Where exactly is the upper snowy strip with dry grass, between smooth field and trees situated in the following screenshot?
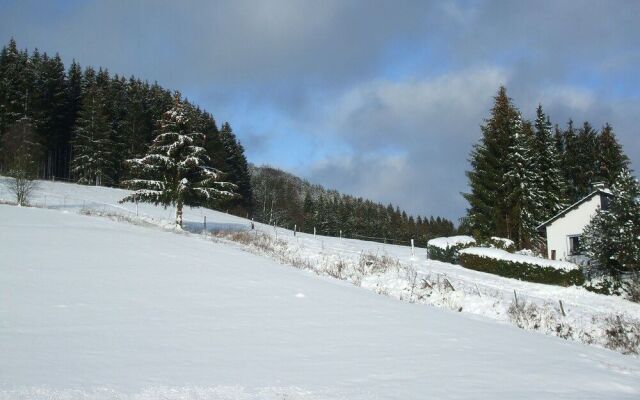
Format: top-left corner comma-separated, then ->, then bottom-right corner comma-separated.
0,177 -> 640,351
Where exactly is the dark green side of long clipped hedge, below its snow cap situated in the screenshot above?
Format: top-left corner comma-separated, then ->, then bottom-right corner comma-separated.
459,253 -> 584,286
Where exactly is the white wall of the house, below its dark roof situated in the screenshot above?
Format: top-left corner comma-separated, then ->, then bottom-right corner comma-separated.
547,195 -> 602,261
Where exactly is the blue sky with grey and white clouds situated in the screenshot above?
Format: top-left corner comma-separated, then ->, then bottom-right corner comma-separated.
0,0 -> 640,221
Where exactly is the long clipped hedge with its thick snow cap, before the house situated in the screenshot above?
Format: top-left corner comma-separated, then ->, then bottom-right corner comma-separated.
459,247 -> 584,286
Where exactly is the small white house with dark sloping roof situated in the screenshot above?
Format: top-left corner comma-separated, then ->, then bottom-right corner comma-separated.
538,185 -> 612,261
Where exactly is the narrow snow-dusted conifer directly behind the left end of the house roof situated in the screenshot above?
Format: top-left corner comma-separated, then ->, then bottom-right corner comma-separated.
532,105 -> 566,219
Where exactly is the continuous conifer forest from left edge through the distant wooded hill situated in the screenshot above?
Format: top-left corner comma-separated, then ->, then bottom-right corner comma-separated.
0,39 -> 456,245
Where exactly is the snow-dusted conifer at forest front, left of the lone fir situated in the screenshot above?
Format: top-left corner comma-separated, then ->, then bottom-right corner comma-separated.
71,68 -> 114,186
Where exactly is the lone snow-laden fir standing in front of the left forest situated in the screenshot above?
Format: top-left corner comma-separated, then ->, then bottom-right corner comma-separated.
121,92 -> 236,227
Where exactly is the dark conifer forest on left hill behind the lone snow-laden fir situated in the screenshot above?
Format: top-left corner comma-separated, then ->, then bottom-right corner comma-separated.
0,39 -> 252,213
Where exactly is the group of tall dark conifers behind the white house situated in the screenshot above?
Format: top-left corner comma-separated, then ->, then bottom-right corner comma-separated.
461,87 -> 629,248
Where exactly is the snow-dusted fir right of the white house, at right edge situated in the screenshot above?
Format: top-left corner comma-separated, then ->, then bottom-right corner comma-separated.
583,169 -> 640,274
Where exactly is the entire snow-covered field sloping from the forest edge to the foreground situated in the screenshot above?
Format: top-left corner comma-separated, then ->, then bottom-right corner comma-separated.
0,178 -> 640,399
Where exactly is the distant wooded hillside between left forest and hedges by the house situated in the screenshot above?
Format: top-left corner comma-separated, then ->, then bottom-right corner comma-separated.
251,166 -> 456,246
